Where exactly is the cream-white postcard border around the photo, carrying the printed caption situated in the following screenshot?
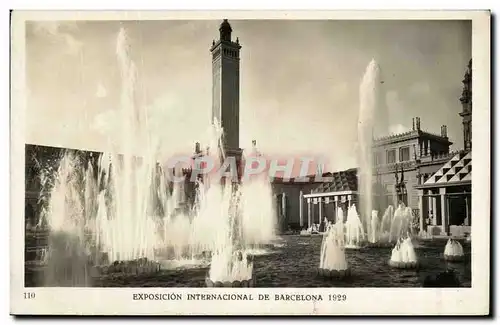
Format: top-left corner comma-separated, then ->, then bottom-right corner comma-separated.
10,11 -> 490,315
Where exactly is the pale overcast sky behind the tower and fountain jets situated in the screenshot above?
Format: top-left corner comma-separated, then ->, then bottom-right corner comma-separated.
26,20 -> 471,170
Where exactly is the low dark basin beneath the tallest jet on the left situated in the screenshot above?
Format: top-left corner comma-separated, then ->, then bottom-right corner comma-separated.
91,258 -> 161,277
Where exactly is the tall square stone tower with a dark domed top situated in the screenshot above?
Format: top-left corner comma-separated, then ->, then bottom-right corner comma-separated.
210,19 -> 241,155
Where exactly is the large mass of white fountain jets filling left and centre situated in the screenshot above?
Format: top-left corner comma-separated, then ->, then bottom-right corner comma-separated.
38,28 -> 275,286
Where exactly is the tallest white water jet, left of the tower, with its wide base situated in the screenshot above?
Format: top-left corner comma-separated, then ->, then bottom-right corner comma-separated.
90,28 -> 164,261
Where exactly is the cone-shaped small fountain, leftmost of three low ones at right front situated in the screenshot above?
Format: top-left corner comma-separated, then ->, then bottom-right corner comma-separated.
318,221 -> 351,279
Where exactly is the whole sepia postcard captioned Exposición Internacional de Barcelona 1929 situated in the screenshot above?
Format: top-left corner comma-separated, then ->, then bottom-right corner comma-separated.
10,11 -> 490,315
